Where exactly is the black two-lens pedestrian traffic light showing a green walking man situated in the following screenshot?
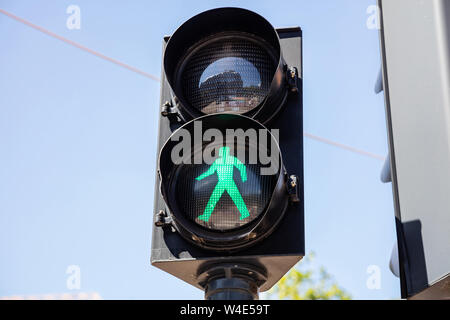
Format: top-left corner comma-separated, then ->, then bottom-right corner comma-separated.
151,8 -> 304,299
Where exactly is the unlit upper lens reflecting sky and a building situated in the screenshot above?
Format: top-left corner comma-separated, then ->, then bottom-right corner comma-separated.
181,35 -> 276,114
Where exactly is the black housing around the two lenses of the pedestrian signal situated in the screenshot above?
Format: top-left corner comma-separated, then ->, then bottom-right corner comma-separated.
151,8 -> 305,291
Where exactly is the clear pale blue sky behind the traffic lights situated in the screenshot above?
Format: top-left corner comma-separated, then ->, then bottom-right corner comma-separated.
0,0 -> 400,299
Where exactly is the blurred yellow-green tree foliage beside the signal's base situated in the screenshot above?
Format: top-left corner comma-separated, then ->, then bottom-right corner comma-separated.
268,253 -> 351,300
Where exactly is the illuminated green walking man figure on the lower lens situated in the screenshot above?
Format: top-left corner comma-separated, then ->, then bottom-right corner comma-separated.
195,147 -> 250,221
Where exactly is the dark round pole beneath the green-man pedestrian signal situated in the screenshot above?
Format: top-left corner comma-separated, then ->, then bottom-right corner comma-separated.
199,263 -> 267,300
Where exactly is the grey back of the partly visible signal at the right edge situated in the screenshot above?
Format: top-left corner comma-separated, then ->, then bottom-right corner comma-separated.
376,0 -> 450,299
